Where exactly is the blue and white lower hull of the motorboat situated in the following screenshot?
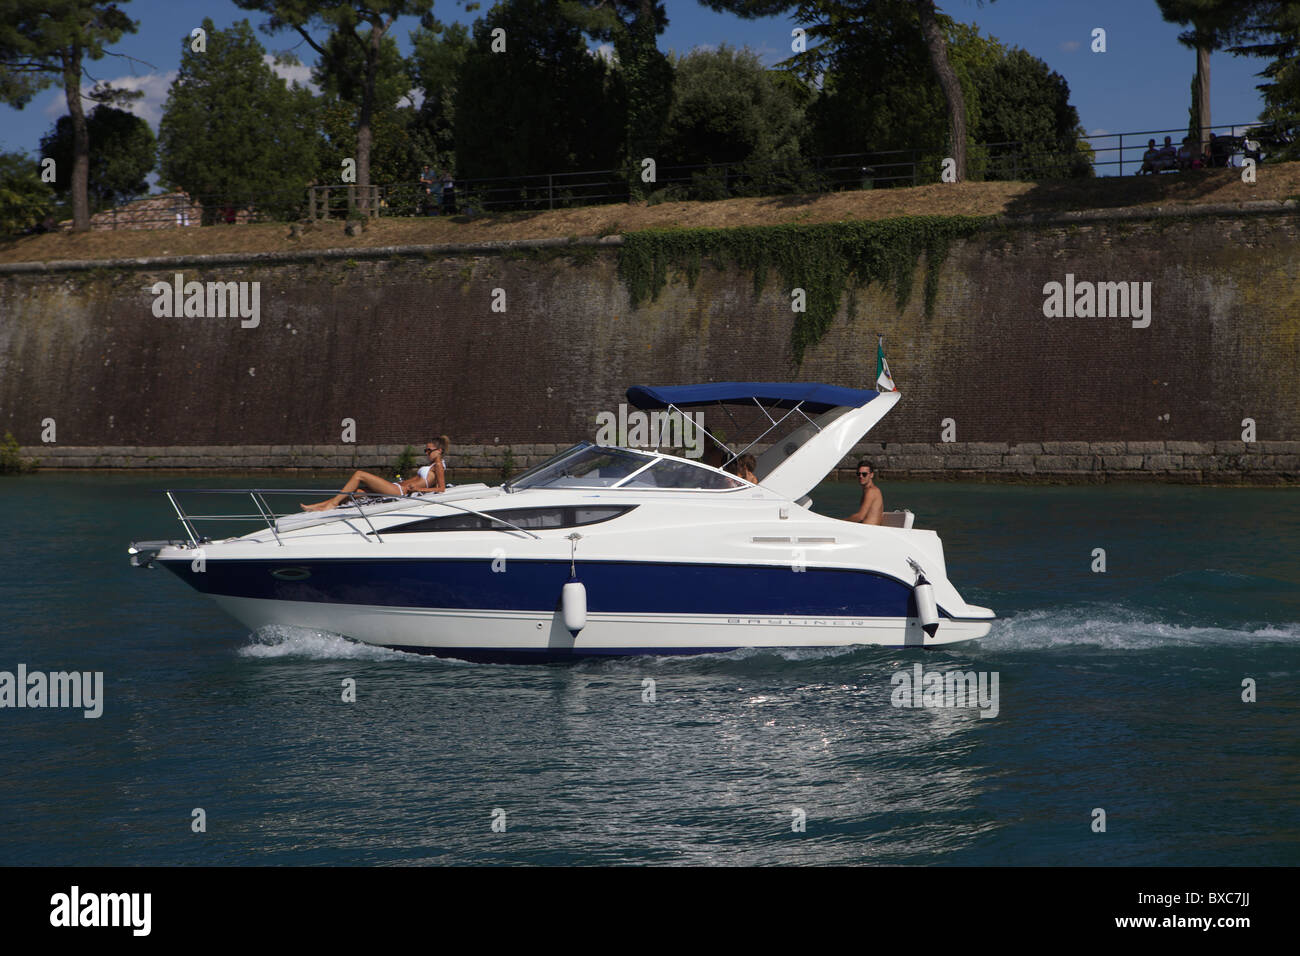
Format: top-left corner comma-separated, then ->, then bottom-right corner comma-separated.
161,559 -> 992,661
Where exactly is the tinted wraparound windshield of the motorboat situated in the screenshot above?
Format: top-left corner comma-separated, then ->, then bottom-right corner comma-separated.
510,445 -> 746,490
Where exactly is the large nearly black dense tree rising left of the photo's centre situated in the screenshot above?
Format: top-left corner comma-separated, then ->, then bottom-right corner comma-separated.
455,0 -> 621,192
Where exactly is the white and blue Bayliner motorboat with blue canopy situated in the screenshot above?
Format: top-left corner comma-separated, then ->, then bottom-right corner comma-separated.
130,382 -> 995,661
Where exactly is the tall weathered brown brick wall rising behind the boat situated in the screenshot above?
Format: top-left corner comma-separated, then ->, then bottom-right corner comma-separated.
0,205 -> 1300,480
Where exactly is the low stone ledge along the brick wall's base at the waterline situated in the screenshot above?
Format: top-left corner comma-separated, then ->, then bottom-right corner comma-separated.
21,441 -> 1300,484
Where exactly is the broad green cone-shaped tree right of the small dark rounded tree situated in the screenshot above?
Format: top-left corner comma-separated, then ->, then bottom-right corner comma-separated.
159,20 -> 316,222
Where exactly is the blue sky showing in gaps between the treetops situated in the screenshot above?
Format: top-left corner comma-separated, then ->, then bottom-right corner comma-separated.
0,0 -> 1265,172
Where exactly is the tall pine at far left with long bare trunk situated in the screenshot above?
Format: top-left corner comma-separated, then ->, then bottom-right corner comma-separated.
0,0 -> 137,229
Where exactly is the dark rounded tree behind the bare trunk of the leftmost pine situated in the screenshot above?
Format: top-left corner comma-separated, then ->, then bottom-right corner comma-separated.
40,103 -> 157,212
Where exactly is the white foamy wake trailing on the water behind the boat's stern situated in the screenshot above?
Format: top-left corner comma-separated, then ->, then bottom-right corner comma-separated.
980,606 -> 1300,650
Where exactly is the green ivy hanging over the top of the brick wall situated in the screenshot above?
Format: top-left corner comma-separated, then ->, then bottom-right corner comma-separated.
619,216 -> 987,364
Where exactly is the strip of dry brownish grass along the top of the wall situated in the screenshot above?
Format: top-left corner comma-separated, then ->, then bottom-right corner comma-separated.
0,163 -> 1300,263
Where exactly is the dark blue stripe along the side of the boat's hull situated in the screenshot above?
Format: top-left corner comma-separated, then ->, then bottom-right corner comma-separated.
161,559 -> 949,618
